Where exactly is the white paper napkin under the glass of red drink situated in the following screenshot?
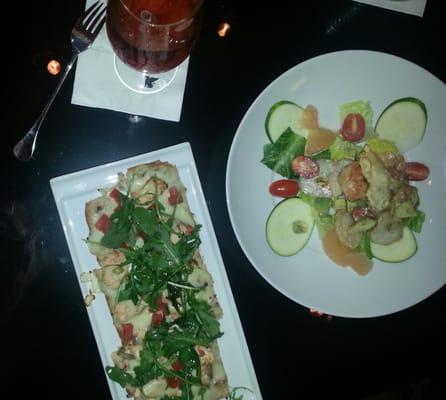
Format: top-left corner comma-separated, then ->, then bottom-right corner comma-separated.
71,0 -> 189,121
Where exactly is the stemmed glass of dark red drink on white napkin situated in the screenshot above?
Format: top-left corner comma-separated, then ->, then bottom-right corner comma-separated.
106,0 -> 204,94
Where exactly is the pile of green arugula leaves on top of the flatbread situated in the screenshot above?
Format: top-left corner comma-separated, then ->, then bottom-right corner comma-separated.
97,188 -> 222,400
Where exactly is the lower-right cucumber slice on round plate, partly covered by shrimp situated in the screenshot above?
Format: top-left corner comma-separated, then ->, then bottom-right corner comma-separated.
370,226 -> 417,263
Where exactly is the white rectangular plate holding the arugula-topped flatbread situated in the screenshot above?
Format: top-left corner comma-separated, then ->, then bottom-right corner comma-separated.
50,143 -> 261,400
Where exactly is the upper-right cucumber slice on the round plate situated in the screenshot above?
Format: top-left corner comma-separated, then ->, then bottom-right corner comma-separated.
375,97 -> 427,153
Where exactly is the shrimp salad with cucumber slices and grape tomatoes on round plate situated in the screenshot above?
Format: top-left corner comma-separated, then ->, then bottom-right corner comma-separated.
261,97 -> 429,275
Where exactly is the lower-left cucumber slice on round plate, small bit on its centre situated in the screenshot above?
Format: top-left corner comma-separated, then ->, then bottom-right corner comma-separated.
266,197 -> 314,256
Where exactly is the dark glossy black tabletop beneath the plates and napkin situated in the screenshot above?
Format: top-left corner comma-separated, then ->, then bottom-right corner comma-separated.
0,0 -> 446,399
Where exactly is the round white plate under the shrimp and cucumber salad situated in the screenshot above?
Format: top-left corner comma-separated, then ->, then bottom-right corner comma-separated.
226,50 -> 446,318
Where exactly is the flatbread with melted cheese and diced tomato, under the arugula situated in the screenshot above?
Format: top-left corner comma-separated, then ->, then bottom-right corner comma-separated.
85,161 -> 229,400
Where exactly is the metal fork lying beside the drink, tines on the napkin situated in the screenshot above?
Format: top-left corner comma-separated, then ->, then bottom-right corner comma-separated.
13,1 -> 106,161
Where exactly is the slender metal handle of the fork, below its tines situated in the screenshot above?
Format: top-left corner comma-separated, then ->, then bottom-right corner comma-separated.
13,52 -> 79,161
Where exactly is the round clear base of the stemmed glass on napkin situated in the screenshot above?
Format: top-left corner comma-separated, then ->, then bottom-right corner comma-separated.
113,55 -> 178,94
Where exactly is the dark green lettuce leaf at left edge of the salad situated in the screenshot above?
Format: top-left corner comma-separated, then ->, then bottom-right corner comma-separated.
262,128 -> 307,178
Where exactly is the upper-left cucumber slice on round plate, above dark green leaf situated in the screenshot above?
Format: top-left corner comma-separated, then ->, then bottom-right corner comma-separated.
265,100 -> 306,143
